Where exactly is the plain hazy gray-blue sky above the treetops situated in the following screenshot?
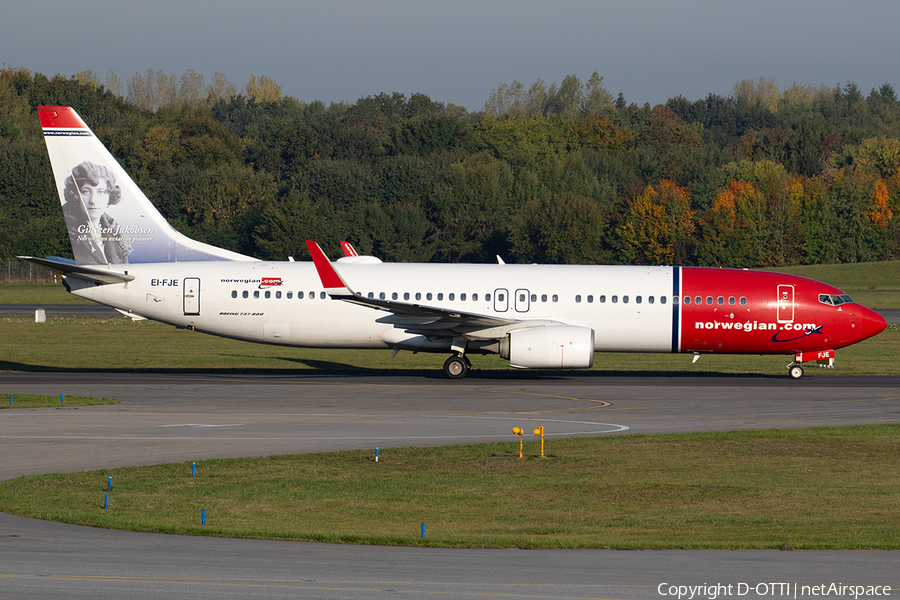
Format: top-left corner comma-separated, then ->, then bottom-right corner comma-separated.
0,0 -> 900,111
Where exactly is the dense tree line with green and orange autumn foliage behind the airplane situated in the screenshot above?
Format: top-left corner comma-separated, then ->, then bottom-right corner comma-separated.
0,68 -> 900,267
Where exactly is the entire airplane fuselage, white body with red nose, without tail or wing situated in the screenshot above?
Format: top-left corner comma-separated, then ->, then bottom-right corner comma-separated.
65,261 -> 883,354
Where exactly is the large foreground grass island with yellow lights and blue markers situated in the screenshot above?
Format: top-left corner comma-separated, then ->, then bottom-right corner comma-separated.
0,425 -> 900,549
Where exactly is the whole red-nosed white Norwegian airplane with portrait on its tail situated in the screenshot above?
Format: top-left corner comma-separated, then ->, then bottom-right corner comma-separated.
23,106 -> 886,378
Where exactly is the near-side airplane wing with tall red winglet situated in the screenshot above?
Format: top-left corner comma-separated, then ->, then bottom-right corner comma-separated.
306,241 -> 534,338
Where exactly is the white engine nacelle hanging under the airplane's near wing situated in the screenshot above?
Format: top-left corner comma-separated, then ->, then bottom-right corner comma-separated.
500,325 -> 594,369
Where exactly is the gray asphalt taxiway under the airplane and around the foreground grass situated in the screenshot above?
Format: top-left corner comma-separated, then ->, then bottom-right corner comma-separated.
0,373 -> 900,599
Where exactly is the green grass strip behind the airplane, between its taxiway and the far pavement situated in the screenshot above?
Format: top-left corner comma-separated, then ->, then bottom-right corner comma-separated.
0,317 -> 900,375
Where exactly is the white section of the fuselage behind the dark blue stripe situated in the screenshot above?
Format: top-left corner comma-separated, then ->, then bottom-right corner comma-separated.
70,261 -> 678,352
